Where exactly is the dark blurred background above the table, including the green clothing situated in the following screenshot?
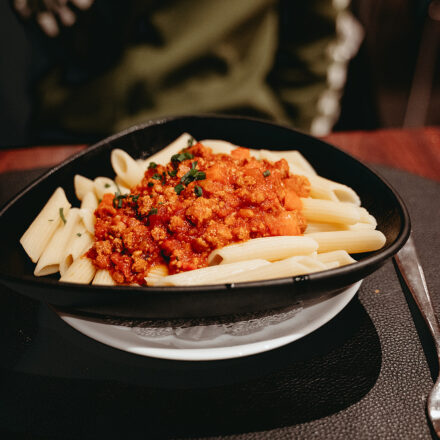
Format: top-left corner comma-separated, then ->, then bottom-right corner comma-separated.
0,0 -> 440,148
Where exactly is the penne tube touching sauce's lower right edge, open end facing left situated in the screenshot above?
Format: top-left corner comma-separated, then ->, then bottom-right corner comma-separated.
208,236 -> 318,266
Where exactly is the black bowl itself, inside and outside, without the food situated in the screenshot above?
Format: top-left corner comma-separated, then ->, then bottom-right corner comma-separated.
0,116 -> 410,318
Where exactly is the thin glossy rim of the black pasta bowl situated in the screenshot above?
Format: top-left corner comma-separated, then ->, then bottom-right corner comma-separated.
0,113 -> 411,295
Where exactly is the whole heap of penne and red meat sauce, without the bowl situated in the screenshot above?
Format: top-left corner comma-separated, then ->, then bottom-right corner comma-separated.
20,133 -> 386,286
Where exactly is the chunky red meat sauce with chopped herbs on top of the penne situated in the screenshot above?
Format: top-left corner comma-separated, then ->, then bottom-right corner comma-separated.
87,143 -> 310,285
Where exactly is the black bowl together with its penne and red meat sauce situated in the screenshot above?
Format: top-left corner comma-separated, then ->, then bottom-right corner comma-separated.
0,117 -> 409,317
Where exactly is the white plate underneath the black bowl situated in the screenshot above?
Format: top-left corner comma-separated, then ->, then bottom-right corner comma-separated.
57,281 -> 362,361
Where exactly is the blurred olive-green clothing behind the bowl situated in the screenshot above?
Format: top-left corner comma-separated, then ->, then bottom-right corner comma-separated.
36,0 -> 337,135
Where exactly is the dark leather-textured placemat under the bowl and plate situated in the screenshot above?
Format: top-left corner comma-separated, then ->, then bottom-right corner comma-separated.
0,167 -> 440,439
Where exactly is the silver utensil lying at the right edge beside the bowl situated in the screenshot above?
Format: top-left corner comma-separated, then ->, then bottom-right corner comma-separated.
394,235 -> 440,437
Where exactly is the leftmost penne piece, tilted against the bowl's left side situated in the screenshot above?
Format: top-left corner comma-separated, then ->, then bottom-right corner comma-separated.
20,188 -> 71,263
